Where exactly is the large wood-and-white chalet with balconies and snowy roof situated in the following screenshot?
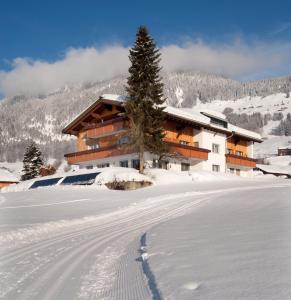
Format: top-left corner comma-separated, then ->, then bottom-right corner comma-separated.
63,94 -> 262,176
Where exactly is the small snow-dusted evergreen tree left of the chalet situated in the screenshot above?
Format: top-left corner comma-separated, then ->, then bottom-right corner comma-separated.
21,142 -> 43,180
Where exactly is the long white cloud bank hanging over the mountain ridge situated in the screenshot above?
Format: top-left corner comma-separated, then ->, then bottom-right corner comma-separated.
0,41 -> 291,96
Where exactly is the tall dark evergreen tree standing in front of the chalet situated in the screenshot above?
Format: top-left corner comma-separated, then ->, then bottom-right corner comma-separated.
125,26 -> 166,173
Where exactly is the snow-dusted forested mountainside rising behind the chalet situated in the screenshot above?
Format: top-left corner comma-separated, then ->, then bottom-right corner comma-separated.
0,72 -> 291,162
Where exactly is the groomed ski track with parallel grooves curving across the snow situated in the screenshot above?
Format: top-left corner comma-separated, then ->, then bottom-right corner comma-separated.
0,180 -> 286,300
